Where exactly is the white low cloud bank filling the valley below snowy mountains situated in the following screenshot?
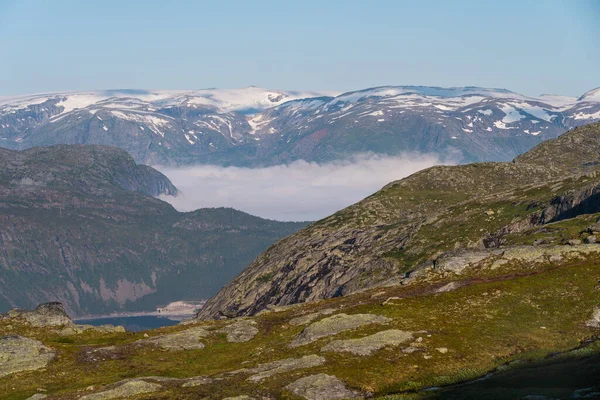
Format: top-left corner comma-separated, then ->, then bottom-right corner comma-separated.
159,154 -> 448,221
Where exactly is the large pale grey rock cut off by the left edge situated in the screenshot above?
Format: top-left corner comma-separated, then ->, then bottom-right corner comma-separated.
0,336 -> 55,377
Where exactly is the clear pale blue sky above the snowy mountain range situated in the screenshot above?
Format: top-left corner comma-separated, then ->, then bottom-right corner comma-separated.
0,0 -> 600,96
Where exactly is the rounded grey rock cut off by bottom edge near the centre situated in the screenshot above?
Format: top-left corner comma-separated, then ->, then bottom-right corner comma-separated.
285,374 -> 363,400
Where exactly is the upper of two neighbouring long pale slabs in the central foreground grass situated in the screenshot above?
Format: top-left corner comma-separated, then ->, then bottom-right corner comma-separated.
290,313 -> 391,347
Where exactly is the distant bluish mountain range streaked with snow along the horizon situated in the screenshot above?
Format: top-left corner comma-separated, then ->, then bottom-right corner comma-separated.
0,86 -> 600,165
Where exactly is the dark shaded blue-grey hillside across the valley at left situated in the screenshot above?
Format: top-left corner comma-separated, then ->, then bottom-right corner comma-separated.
0,145 -> 303,315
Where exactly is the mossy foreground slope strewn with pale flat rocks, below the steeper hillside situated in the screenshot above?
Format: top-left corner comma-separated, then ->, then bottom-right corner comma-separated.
0,230 -> 600,400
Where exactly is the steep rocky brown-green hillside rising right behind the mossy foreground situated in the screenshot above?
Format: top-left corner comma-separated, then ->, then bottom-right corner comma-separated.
199,124 -> 600,318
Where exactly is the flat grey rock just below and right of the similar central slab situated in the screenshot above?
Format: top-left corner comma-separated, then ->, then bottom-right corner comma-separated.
321,329 -> 412,356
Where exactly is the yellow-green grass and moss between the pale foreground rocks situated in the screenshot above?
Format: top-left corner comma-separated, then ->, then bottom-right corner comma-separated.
0,250 -> 600,399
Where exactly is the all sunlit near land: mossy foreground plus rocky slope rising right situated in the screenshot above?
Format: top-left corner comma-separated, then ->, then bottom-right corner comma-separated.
0,124 -> 600,400
